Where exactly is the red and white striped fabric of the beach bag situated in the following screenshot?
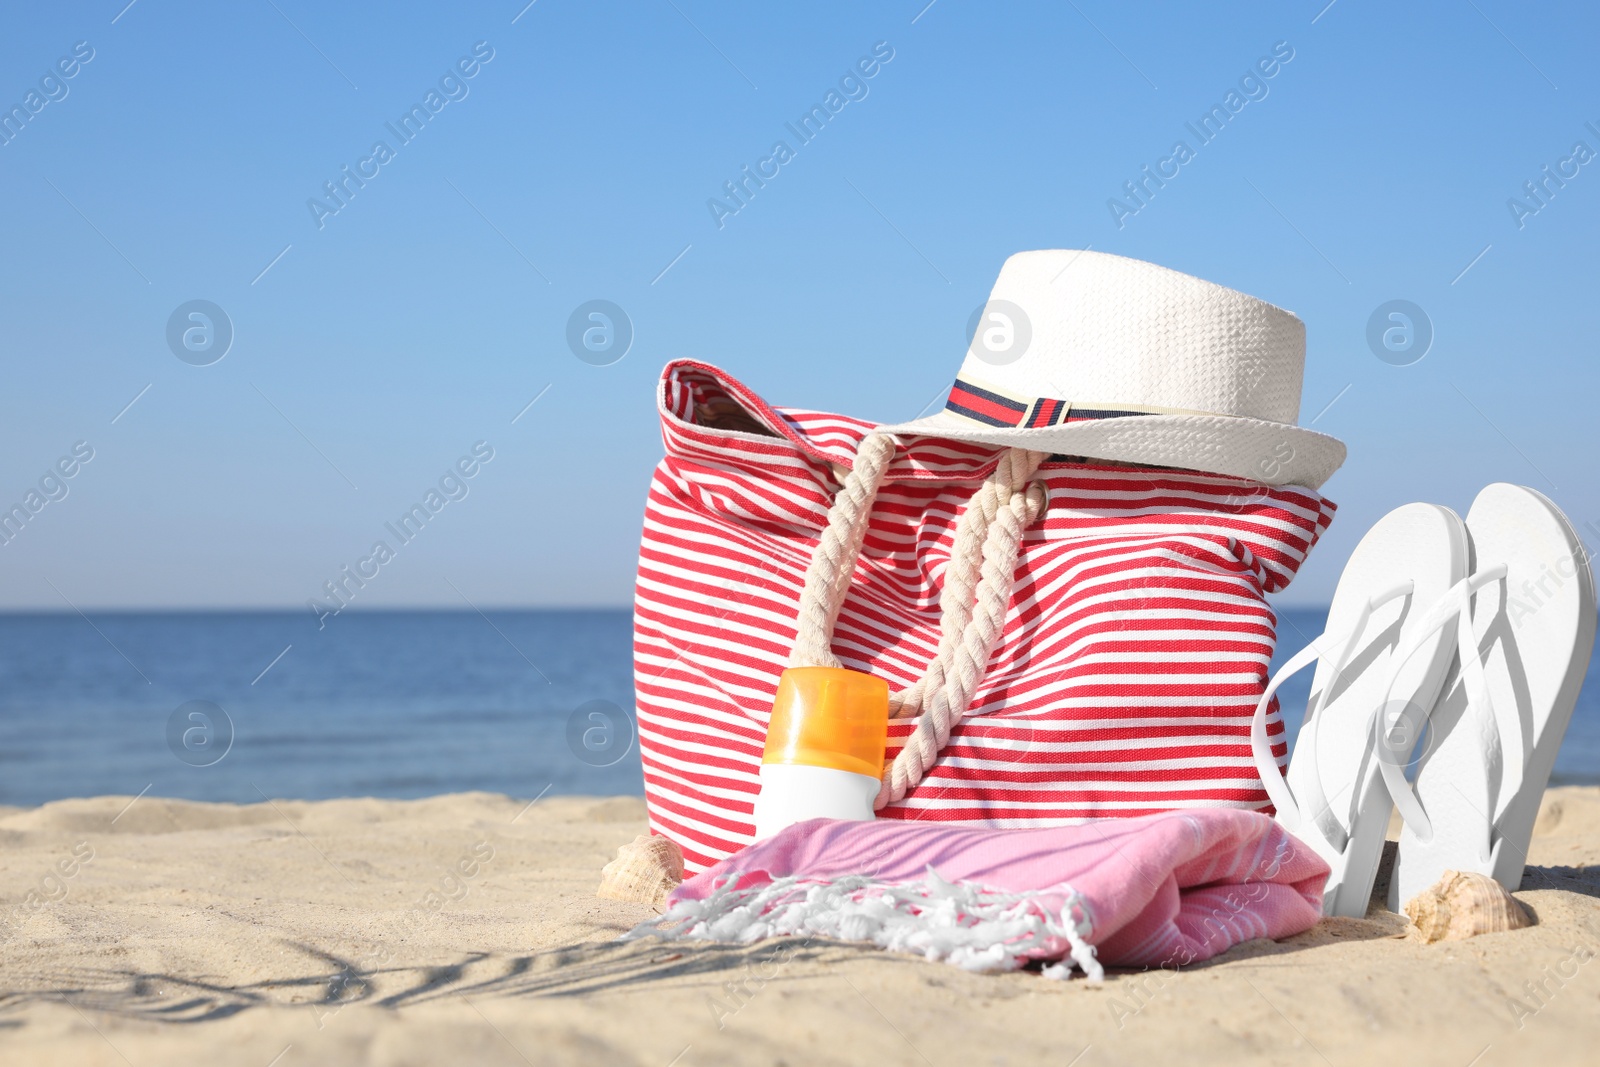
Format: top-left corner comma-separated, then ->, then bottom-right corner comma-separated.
634,360 -> 1334,873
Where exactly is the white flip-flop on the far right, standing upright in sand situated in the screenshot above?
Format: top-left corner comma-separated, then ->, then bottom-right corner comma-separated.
1382,482 -> 1595,910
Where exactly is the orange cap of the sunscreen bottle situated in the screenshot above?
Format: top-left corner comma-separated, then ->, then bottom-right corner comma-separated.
762,667 -> 890,777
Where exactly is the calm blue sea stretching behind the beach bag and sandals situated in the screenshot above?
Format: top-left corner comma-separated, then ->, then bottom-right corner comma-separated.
0,609 -> 1600,805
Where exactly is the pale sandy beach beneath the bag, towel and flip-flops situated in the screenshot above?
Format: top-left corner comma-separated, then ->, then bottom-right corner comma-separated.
0,787 -> 1600,1067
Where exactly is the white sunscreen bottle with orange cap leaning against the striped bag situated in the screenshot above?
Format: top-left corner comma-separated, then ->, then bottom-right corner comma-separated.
755,667 -> 890,840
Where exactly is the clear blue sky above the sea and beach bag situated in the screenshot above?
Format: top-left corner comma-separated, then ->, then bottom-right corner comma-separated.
0,0 -> 1600,609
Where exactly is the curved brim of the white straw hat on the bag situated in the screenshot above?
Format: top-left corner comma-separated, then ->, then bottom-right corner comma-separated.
878,411 -> 1346,490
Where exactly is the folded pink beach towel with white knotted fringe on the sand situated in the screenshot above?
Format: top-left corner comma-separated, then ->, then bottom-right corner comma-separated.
632,808 -> 1328,979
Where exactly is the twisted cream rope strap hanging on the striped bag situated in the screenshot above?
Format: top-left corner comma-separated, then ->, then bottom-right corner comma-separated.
789,434 -> 1046,808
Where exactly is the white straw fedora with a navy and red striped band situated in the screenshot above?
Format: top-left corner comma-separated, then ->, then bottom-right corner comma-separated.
880,250 -> 1344,490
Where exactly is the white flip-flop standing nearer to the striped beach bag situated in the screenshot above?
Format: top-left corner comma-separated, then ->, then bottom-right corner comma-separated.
1250,504 -> 1467,917
